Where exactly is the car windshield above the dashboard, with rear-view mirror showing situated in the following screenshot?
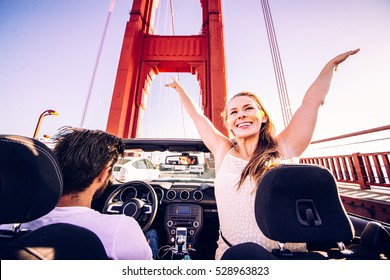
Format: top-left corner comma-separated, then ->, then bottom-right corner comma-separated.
113,139 -> 215,183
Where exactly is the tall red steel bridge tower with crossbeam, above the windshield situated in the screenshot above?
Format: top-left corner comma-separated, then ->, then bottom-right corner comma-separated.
106,0 -> 227,138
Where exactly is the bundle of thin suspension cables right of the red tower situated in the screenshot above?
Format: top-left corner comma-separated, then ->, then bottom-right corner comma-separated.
261,0 -> 292,127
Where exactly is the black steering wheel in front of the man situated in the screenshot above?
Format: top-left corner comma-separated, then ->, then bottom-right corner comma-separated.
103,181 -> 158,232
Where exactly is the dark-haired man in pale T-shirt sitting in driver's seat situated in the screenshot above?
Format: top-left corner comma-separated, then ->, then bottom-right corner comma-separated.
1,127 -> 152,260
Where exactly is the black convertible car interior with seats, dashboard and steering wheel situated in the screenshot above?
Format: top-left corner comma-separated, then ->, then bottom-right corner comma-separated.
0,135 -> 390,260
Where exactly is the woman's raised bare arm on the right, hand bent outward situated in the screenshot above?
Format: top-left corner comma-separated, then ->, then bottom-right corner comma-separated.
277,49 -> 359,158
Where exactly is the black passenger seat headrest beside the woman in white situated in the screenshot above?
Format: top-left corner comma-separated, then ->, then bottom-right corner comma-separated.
255,165 -> 354,243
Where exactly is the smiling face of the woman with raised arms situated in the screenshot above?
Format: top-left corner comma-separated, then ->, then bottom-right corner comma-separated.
226,96 -> 266,138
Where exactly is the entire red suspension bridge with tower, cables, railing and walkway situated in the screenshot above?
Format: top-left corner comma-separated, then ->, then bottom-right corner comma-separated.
80,0 -> 390,223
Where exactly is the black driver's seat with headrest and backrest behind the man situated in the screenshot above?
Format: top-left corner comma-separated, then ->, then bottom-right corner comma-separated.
0,135 -> 108,260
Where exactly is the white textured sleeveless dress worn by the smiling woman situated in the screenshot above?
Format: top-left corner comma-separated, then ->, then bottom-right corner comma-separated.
214,151 -> 306,260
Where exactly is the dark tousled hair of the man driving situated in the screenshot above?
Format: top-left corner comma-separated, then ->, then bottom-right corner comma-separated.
53,127 -> 124,194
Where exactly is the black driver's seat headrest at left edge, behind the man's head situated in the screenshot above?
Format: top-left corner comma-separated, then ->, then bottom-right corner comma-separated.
0,135 -> 63,224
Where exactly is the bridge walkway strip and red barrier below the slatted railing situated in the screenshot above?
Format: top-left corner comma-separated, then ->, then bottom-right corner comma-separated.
337,182 -> 390,224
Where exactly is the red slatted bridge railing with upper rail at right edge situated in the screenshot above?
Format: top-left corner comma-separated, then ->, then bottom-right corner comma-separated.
300,125 -> 390,189
